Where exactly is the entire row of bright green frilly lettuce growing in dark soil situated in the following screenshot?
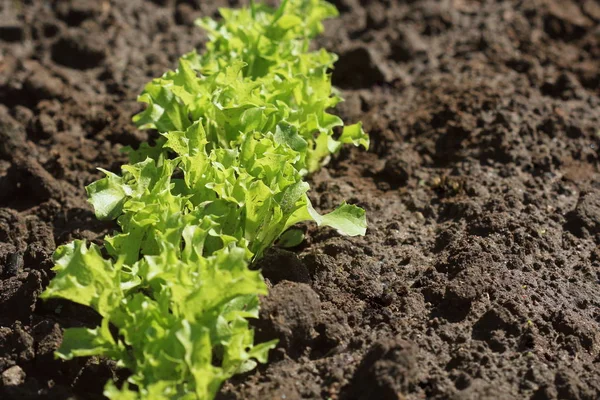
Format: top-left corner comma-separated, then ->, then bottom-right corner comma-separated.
43,0 -> 369,399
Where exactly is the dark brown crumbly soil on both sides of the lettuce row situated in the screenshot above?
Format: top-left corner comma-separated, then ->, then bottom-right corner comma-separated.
0,0 -> 600,400
